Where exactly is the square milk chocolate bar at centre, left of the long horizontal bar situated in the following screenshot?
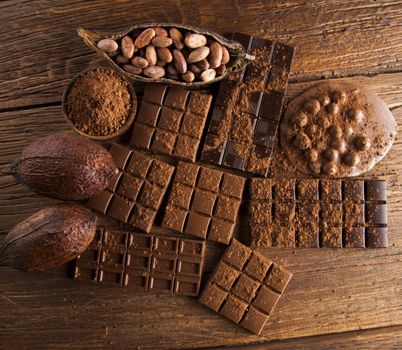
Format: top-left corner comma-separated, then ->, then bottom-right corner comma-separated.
162,162 -> 245,244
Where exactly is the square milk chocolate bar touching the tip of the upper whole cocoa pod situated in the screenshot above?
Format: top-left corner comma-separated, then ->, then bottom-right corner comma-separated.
87,144 -> 174,232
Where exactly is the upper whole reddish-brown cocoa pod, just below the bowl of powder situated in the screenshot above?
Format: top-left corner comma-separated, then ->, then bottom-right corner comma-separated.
11,134 -> 117,200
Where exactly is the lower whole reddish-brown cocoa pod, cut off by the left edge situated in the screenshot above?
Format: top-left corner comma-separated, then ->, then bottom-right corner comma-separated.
0,204 -> 96,271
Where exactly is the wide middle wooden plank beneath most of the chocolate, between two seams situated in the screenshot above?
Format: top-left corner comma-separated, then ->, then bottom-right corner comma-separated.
0,73 -> 402,349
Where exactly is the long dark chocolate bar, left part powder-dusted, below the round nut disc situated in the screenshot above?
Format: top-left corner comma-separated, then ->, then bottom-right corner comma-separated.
249,179 -> 388,248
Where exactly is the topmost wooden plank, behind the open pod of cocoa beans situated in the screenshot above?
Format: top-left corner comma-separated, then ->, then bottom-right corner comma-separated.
0,0 -> 402,109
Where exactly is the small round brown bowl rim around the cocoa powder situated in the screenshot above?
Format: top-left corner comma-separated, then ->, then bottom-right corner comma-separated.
62,65 -> 138,141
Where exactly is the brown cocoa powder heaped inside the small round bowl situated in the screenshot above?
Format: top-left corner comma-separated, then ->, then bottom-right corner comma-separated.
66,68 -> 132,136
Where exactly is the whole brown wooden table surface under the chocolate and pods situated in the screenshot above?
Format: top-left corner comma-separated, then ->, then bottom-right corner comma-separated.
0,0 -> 402,350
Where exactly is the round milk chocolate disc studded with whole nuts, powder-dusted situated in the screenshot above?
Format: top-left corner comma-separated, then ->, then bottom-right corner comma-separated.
280,82 -> 397,177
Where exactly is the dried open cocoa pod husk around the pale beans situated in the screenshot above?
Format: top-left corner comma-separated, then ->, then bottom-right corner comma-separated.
78,23 -> 253,88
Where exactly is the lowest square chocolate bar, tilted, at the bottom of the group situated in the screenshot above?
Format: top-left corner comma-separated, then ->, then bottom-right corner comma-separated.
198,240 -> 292,334
